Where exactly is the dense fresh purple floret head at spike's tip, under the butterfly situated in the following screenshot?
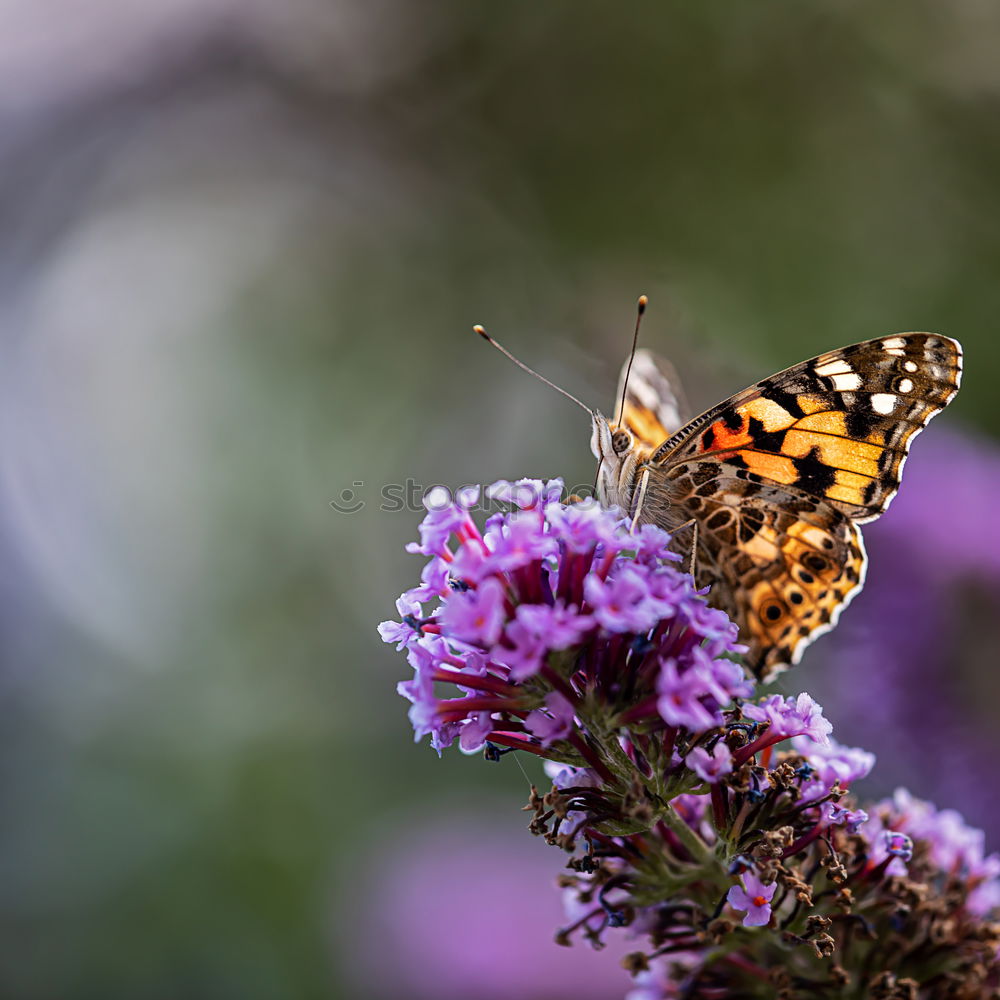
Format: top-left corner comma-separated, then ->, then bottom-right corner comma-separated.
379,480 -> 752,768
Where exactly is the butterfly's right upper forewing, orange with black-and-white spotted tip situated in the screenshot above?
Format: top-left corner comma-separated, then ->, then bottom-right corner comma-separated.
650,333 -> 962,523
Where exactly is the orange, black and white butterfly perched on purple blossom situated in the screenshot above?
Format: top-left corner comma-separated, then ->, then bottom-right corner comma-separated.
591,333 -> 962,680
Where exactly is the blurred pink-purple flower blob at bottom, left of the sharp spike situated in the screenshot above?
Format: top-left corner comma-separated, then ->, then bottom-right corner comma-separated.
337,808 -> 635,1000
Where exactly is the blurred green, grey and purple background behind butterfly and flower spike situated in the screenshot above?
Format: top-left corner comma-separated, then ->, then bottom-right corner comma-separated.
0,0 -> 1000,1000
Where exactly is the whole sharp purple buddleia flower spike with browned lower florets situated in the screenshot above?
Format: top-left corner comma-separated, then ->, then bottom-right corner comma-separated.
380,472 -> 1000,1000
